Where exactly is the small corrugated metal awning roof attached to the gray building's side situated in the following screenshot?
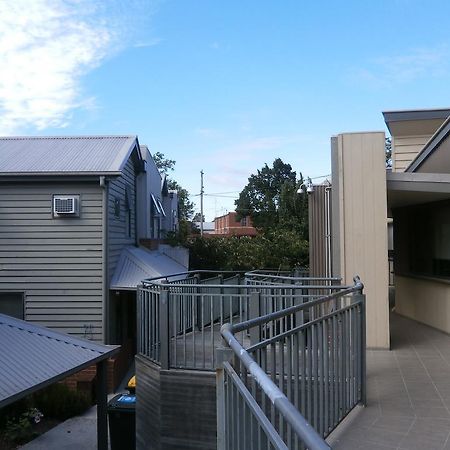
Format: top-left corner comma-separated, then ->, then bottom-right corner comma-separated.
110,247 -> 187,290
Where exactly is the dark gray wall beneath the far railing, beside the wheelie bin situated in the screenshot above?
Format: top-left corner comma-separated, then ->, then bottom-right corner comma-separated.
135,355 -> 217,450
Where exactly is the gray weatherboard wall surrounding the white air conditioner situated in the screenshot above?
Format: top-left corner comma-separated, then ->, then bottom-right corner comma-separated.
0,180 -> 102,341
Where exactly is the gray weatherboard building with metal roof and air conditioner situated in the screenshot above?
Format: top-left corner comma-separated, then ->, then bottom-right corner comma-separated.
0,136 -> 187,350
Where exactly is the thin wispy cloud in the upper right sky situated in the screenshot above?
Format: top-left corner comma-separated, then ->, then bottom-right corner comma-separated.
351,46 -> 449,88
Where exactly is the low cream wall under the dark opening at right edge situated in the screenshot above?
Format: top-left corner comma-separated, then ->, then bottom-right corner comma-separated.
395,275 -> 450,333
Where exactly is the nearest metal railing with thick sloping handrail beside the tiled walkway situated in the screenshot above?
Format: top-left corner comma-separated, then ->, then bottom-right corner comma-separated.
216,278 -> 366,450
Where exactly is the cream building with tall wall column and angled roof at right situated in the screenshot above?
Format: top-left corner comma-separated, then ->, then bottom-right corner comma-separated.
309,109 -> 450,348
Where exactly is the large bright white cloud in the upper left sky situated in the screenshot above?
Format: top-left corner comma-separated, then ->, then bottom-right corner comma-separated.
0,0 -> 157,134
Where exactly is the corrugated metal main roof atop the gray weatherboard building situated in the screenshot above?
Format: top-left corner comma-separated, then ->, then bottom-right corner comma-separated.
0,136 -> 137,175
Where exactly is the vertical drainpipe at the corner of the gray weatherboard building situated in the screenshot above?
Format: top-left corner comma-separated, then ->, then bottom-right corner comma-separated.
99,176 -> 110,344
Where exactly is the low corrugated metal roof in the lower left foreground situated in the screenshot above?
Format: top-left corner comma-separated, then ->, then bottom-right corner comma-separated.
0,314 -> 119,407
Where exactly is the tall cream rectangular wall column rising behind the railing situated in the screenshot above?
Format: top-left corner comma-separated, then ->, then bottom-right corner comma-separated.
332,132 -> 389,348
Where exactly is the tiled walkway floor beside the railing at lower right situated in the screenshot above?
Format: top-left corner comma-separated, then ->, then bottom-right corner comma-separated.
333,314 -> 450,450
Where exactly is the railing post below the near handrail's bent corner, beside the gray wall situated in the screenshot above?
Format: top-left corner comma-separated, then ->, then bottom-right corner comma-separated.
216,347 -> 233,450
